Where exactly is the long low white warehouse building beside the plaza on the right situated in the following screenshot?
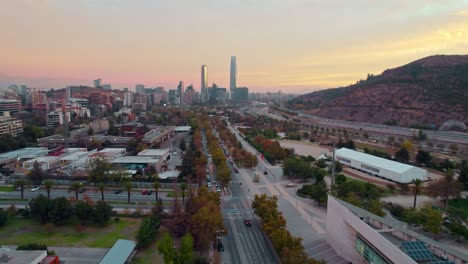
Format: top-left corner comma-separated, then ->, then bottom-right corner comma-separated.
335,148 -> 427,183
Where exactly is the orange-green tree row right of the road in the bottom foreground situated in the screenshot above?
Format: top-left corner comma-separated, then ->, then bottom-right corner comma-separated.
252,194 -> 324,264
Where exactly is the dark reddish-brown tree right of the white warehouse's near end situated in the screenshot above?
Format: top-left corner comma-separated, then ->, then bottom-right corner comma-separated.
426,169 -> 462,207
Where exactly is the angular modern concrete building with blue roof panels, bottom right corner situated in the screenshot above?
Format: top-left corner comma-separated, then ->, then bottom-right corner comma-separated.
326,196 -> 468,264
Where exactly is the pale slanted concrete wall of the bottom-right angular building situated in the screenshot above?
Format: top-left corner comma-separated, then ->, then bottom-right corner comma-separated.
327,196 -> 416,264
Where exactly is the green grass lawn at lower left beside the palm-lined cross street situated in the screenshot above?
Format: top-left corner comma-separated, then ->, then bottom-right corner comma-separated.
0,218 -> 141,248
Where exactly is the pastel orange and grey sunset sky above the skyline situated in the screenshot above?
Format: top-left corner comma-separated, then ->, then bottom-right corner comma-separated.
0,0 -> 468,93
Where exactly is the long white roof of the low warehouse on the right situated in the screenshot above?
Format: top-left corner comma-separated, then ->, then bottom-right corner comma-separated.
335,148 -> 424,173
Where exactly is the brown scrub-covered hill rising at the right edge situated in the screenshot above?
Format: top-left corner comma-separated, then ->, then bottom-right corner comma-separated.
288,55 -> 468,127
